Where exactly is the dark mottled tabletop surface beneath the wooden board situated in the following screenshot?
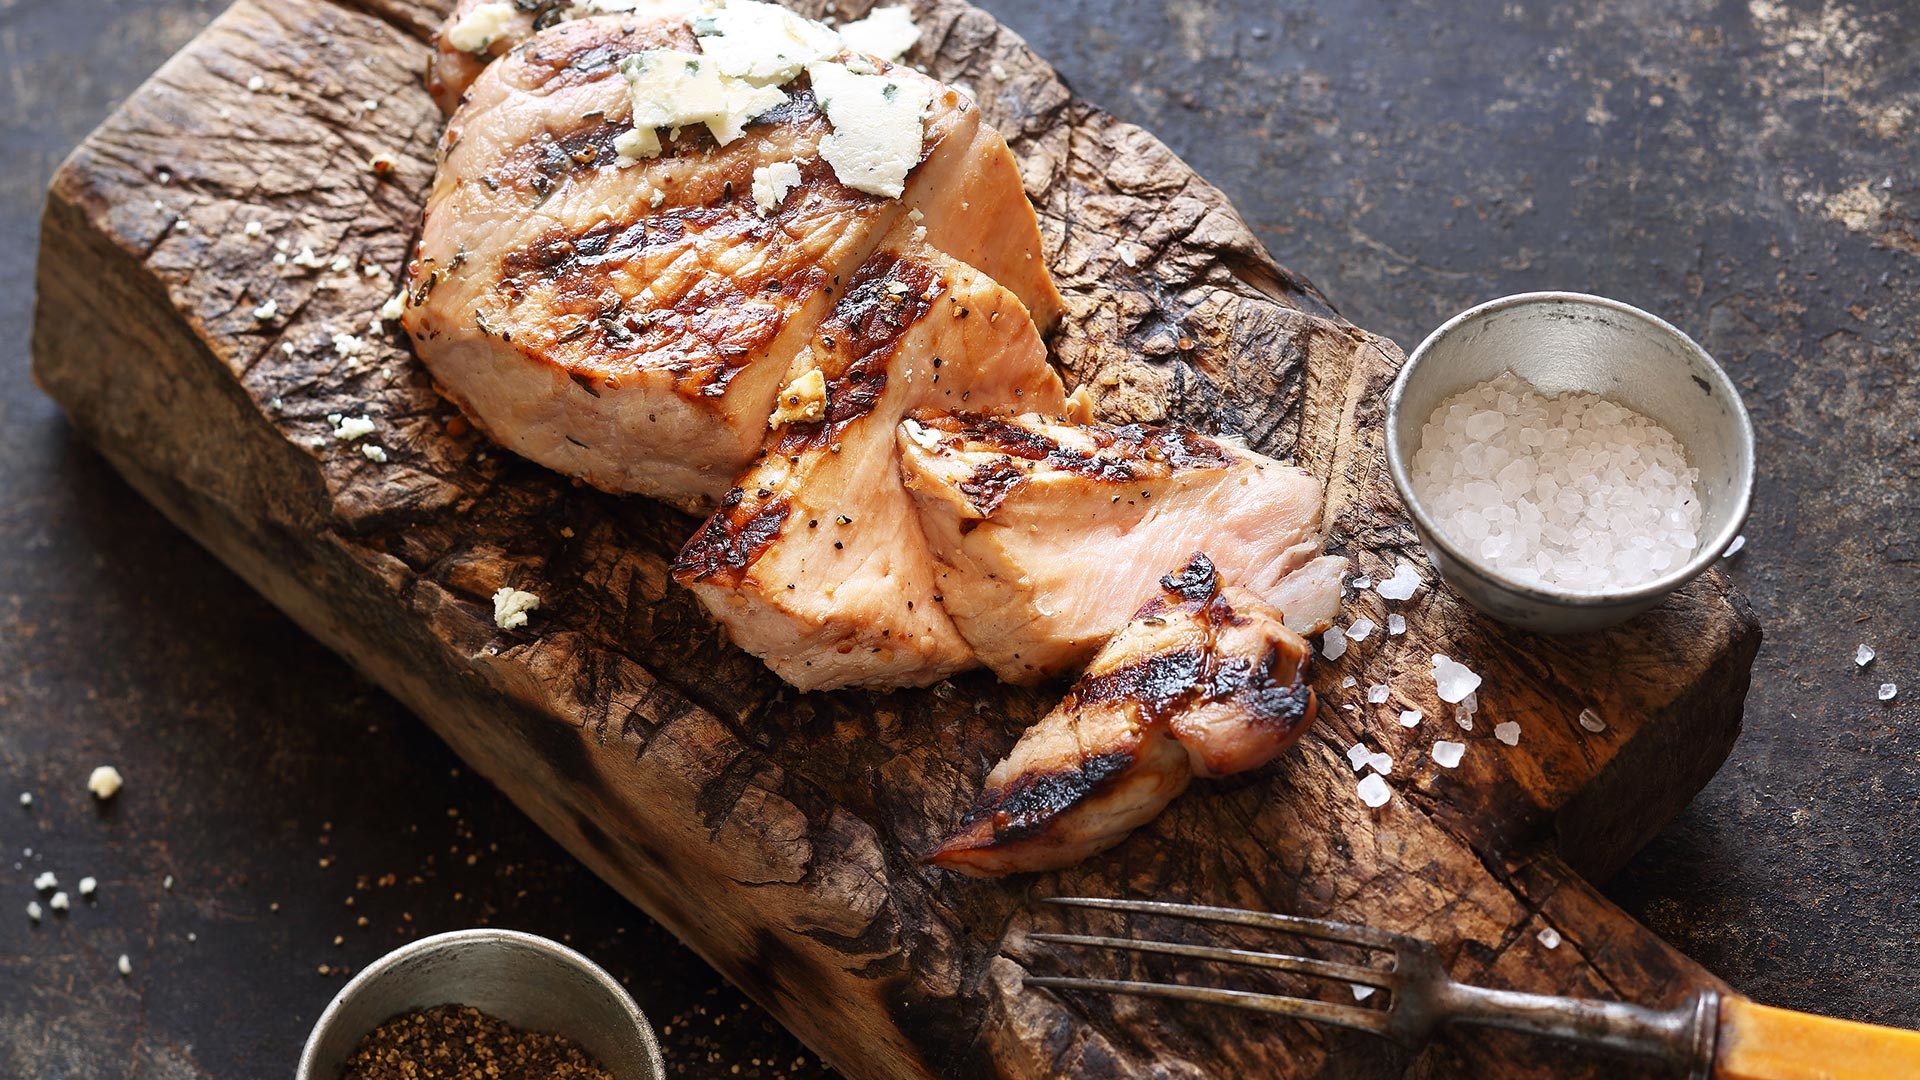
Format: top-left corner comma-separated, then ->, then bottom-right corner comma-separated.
0,0 -> 1920,1078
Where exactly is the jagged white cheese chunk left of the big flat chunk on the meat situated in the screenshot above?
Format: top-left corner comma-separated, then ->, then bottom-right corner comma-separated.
614,50 -> 787,160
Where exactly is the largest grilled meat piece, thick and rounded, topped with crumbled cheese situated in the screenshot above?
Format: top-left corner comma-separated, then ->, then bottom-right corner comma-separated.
403,15 -> 1060,507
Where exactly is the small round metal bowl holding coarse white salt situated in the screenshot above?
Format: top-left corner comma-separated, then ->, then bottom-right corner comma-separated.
1386,292 -> 1753,634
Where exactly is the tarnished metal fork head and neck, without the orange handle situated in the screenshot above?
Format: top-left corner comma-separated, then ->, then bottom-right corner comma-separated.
1025,897 -> 1720,1078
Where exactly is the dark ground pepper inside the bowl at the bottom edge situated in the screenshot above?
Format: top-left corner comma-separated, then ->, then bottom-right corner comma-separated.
340,1005 -> 612,1080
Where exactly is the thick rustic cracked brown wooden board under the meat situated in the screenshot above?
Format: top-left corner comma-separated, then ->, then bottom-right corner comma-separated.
33,0 -> 1761,1078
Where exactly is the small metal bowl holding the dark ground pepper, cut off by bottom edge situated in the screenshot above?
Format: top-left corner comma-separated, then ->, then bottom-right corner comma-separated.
298,930 -> 666,1080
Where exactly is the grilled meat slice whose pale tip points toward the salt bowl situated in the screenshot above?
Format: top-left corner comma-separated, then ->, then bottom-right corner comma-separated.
899,411 -> 1344,684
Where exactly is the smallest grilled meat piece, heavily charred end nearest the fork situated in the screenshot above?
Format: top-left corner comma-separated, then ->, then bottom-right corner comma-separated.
929,553 -> 1315,876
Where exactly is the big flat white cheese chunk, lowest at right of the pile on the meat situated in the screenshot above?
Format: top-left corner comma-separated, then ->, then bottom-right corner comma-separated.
806,63 -> 933,198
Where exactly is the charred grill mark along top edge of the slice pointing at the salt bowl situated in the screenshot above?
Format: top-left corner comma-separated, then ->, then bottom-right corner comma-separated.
914,413 -> 1235,517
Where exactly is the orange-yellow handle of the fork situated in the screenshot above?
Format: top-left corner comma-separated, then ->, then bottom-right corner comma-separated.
1713,995 -> 1920,1080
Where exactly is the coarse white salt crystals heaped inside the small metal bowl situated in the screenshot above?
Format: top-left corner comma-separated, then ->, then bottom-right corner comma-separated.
1411,373 -> 1701,592
